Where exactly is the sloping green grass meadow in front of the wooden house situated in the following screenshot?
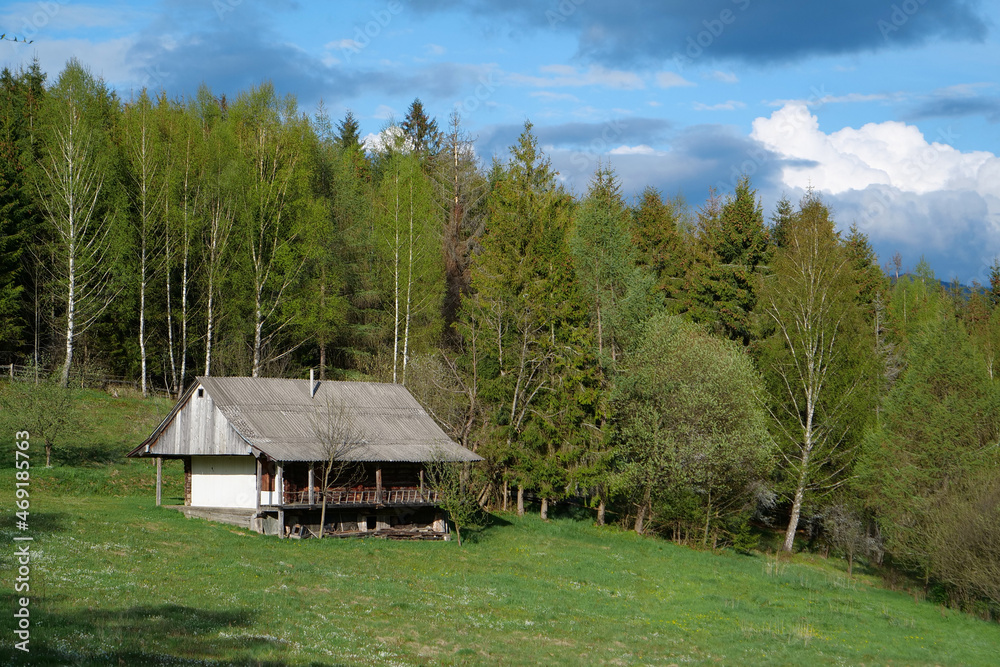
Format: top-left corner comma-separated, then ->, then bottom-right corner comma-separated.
0,463 -> 1000,666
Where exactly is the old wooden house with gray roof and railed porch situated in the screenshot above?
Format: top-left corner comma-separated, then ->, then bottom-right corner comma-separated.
129,377 -> 481,537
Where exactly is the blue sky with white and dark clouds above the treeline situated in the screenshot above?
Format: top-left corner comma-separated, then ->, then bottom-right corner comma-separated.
0,0 -> 1000,282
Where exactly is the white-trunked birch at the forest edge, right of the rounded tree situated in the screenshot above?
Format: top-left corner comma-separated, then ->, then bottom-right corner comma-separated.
761,195 -> 874,552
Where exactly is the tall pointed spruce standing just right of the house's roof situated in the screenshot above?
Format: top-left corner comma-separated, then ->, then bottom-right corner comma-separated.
463,123 -> 579,514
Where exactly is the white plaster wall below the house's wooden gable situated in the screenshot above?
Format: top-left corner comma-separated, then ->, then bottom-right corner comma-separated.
191,456 -> 256,509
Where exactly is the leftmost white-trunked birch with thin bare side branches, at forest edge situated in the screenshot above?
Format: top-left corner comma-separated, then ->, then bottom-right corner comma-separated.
36,60 -> 115,387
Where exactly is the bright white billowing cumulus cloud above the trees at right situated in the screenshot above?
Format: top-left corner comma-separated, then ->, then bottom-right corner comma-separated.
750,102 -> 1000,282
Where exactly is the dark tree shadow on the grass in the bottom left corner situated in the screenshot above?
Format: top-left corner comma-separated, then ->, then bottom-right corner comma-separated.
0,595 -> 350,667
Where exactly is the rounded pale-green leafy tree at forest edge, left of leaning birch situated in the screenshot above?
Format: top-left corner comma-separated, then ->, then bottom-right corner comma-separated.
613,314 -> 775,544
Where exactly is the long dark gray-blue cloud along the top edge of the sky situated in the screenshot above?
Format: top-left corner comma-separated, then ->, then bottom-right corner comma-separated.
413,0 -> 989,69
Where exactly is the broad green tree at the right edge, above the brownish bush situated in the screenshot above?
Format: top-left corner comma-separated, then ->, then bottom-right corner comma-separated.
856,313 -> 1000,578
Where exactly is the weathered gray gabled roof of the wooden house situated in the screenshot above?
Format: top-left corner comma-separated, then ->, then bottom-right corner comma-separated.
129,377 -> 482,462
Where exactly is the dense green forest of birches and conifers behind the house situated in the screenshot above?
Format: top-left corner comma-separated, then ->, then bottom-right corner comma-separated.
0,61 -> 1000,604
